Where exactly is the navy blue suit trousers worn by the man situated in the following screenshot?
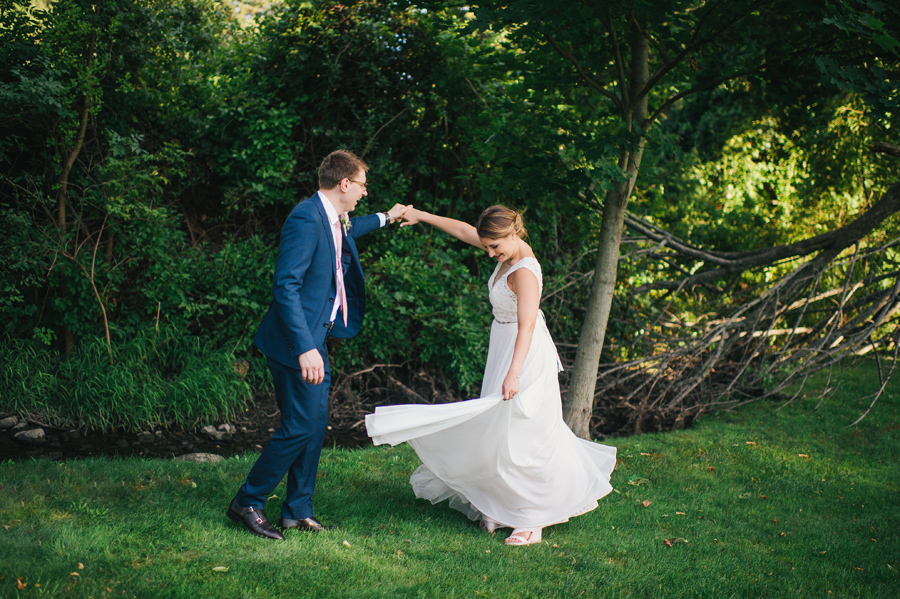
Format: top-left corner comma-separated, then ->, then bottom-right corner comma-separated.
236,344 -> 331,520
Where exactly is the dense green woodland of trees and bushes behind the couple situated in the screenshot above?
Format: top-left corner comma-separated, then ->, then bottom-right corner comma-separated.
0,0 -> 900,435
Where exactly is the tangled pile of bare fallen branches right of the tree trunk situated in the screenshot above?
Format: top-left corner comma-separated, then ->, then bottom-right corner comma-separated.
592,183 -> 900,437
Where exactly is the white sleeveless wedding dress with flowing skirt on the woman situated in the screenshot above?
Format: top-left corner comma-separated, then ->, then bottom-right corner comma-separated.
366,257 -> 616,530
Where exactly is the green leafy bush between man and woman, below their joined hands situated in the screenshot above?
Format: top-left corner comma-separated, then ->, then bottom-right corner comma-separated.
332,230 -> 491,394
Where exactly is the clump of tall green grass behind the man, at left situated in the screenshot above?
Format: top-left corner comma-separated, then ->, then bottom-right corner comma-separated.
0,328 -> 250,431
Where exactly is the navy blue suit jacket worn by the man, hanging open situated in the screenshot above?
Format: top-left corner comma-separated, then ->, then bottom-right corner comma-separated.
253,194 -> 381,370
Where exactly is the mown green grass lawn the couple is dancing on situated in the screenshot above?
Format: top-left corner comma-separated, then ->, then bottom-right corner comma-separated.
0,366 -> 900,599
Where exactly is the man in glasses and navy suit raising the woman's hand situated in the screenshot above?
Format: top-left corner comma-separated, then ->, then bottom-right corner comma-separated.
227,150 -> 407,540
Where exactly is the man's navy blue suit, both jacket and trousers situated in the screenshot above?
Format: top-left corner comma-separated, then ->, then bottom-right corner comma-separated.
235,194 -> 381,520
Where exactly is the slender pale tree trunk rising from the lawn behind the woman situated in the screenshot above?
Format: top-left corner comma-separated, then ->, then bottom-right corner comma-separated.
563,25 -> 650,439
